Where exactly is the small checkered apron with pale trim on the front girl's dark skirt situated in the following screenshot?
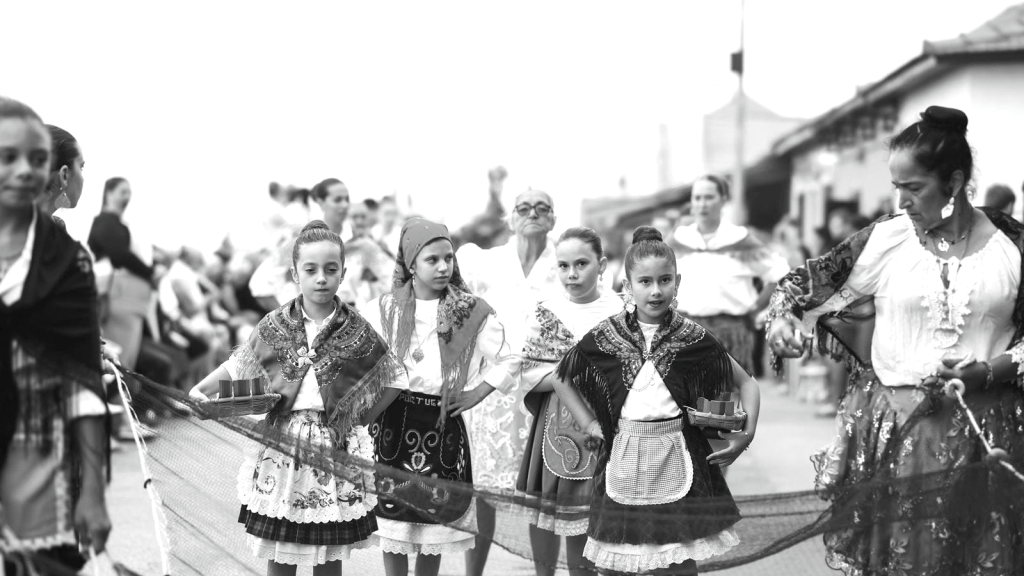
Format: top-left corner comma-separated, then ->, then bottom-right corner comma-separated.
604,418 -> 693,506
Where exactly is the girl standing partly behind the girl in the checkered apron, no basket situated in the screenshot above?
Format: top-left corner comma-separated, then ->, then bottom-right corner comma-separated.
516,228 -> 623,576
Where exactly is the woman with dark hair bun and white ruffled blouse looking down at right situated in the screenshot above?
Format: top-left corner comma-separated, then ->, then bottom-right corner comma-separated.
768,106 -> 1024,576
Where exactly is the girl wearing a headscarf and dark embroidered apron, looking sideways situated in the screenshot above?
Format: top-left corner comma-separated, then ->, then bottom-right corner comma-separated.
364,218 -> 519,576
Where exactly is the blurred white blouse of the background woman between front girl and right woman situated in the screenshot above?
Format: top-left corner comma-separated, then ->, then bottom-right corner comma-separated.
674,222 -> 790,316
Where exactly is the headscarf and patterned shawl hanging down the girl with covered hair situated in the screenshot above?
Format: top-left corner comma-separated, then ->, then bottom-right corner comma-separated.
380,218 -> 494,425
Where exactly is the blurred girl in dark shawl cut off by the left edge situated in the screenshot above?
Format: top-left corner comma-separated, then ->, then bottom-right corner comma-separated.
0,97 -> 111,573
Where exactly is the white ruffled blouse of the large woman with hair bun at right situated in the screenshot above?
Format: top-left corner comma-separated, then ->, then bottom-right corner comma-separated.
804,216 -> 1021,386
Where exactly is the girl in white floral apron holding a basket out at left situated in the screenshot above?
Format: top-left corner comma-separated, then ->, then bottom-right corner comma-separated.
194,220 -> 409,576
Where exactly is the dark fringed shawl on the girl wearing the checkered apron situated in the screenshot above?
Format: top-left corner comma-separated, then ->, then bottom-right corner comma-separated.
556,311 -> 732,438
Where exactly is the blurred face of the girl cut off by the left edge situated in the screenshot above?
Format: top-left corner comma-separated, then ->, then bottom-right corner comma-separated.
0,118 -> 50,209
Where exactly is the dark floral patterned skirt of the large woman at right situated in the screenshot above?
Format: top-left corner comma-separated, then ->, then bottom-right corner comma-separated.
812,371 -> 1024,576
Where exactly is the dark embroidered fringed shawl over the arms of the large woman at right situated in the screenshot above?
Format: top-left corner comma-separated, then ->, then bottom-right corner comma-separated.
768,208 -> 1024,373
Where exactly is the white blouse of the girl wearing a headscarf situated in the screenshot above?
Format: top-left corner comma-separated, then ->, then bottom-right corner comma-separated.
359,296 -> 519,396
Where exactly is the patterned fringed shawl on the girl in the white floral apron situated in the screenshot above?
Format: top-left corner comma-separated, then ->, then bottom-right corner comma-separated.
232,295 -> 404,443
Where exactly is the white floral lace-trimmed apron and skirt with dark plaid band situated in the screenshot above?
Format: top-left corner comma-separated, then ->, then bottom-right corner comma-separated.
239,410 -> 377,566
